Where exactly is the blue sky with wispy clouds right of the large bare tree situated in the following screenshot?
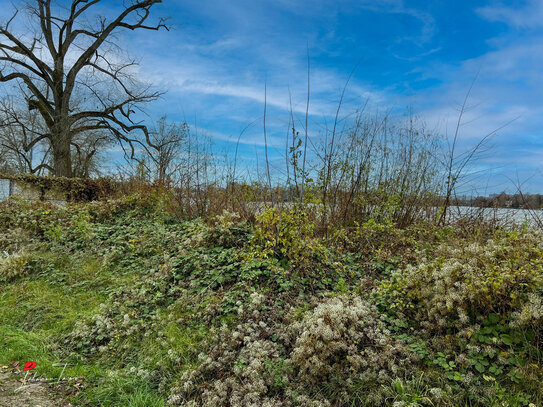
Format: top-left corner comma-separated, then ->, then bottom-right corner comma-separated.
4,0 -> 543,193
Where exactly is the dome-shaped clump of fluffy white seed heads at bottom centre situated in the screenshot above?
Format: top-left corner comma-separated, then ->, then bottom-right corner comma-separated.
291,297 -> 417,402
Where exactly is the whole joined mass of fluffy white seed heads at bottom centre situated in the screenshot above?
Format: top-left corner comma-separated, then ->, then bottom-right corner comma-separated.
169,294 -> 416,407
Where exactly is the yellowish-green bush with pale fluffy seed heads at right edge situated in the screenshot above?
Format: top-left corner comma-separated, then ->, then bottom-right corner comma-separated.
398,234 -> 543,330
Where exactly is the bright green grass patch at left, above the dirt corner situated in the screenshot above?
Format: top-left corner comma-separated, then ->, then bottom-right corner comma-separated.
0,200 -> 175,406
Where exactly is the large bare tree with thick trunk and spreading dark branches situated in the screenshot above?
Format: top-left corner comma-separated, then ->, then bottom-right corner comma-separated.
0,0 -> 167,177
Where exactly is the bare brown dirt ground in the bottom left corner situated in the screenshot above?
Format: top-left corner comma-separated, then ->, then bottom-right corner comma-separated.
0,370 -> 71,407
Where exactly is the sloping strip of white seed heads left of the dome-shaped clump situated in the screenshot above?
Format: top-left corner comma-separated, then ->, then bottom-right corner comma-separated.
169,293 -> 298,407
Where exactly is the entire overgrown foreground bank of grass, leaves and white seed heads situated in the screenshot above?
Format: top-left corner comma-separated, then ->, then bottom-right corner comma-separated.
0,189 -> 543,407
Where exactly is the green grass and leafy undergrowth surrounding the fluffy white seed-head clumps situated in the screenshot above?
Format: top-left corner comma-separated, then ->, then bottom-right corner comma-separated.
0,200 -> 543,406
